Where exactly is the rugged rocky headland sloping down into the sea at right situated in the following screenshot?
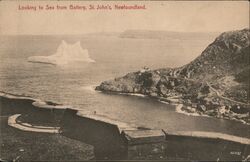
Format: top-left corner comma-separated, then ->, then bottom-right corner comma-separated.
96,29 -> 250,123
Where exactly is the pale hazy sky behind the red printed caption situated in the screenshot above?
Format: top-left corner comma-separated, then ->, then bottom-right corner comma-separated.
0,1 -> 249,35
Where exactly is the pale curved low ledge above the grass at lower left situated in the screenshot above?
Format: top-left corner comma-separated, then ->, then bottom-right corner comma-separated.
8,114 -> 59,133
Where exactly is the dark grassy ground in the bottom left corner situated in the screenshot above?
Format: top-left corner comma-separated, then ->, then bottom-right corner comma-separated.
0,116 -> 94,161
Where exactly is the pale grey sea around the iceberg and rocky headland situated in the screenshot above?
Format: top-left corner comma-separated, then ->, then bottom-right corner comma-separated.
0,34 -> 250,137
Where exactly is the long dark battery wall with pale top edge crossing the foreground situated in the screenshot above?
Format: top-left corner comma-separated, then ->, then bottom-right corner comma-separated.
0,97 -> 250,161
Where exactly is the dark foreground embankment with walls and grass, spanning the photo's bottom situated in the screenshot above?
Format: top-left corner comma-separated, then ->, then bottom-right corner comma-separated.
0,94 -> 250,161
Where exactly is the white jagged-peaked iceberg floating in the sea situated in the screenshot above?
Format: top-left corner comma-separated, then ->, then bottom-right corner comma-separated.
28,40 -> 95,65
